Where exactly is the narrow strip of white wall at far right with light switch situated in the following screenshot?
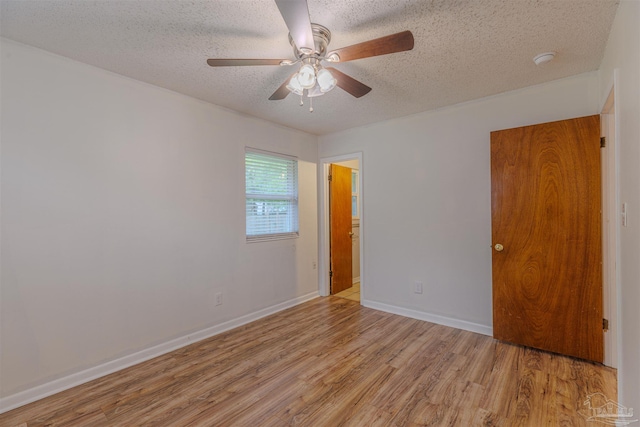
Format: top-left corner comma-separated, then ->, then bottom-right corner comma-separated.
600,0 -> 640,413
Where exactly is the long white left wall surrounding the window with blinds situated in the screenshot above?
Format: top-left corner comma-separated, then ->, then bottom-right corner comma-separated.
0,40 -> 317,404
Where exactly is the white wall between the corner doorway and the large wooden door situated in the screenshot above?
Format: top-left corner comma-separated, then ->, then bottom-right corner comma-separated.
319,71 -> 598,333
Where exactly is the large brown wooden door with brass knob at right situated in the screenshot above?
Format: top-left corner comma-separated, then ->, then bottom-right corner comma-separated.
491,116 -> 603,362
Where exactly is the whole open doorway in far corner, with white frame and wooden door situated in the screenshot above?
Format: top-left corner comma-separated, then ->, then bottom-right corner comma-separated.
319,153 -> 364,302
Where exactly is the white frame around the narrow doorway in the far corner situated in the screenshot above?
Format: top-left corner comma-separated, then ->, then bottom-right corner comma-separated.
318,151 -> 366,304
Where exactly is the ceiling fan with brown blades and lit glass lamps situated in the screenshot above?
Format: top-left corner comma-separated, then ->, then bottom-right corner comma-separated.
207,0 -> 413,111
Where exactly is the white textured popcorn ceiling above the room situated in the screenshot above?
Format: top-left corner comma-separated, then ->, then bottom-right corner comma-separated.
0,0 -> 618,135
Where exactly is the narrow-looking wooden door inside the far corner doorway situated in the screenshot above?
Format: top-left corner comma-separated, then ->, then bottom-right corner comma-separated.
329,164 -> 353,294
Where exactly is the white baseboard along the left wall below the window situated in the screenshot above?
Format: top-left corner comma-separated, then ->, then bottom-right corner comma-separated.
0,291 -> 319,414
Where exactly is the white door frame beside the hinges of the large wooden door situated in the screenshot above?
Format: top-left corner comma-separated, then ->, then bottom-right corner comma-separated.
600,70 -> 622,368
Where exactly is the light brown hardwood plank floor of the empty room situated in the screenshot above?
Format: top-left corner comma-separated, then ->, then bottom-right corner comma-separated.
0,297 -> 616,427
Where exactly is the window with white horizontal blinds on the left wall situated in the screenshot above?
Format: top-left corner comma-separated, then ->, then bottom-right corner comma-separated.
244,148 -> 298,242
